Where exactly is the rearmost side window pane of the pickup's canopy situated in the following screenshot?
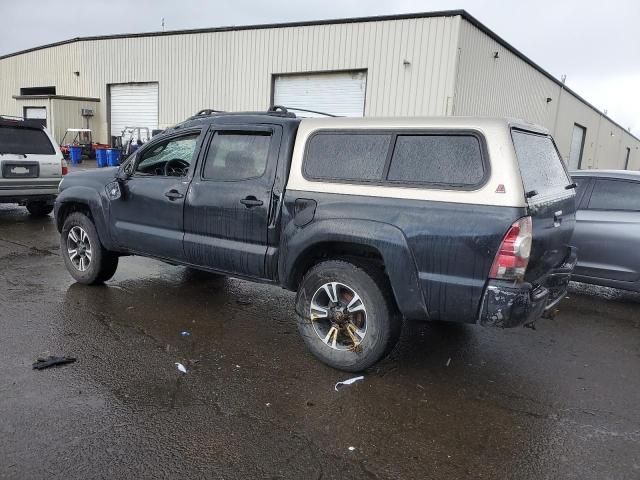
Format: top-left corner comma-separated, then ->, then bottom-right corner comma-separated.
387,135 -> 484,186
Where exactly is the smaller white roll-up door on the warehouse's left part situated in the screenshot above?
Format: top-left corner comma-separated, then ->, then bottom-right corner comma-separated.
110,83 -> 158,136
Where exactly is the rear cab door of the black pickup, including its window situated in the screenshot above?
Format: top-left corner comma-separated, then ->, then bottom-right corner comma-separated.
184,124 -> 282,278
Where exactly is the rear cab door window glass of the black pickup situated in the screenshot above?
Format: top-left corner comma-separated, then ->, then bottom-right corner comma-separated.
202,131 -> 271,180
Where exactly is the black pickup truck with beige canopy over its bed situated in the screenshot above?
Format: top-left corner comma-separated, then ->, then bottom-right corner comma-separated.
55,108 -> 576,371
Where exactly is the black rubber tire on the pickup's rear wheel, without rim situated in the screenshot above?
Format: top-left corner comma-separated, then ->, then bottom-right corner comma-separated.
296,260 -> 402,372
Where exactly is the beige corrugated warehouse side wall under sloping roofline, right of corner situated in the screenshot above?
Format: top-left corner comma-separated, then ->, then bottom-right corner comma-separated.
453,20 -> 640,170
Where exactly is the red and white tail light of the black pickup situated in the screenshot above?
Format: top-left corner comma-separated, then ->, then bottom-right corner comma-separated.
489,217 -> 533,281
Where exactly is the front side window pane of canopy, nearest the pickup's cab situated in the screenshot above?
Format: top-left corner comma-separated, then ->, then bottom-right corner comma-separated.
304,133 -> 391,182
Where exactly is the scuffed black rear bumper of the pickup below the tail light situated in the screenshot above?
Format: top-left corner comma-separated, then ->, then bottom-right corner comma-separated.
478,247 -> 577,328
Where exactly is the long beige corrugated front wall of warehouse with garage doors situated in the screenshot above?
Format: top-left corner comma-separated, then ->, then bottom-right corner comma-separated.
0,16 -> 461,140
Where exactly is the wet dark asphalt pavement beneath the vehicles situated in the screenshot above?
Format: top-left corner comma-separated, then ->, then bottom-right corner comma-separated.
0,206 -> 640,479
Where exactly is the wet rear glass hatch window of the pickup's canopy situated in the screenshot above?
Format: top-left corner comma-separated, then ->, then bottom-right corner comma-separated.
512,130 -> 571,200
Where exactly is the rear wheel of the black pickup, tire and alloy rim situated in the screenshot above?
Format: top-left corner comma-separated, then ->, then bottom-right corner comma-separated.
296,260 -> 402,372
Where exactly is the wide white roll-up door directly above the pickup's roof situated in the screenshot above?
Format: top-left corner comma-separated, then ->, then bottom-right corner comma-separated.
273,71 -> 367,117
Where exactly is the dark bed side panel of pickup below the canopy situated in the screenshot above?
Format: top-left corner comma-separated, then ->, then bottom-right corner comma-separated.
280,191 -> 525,323
